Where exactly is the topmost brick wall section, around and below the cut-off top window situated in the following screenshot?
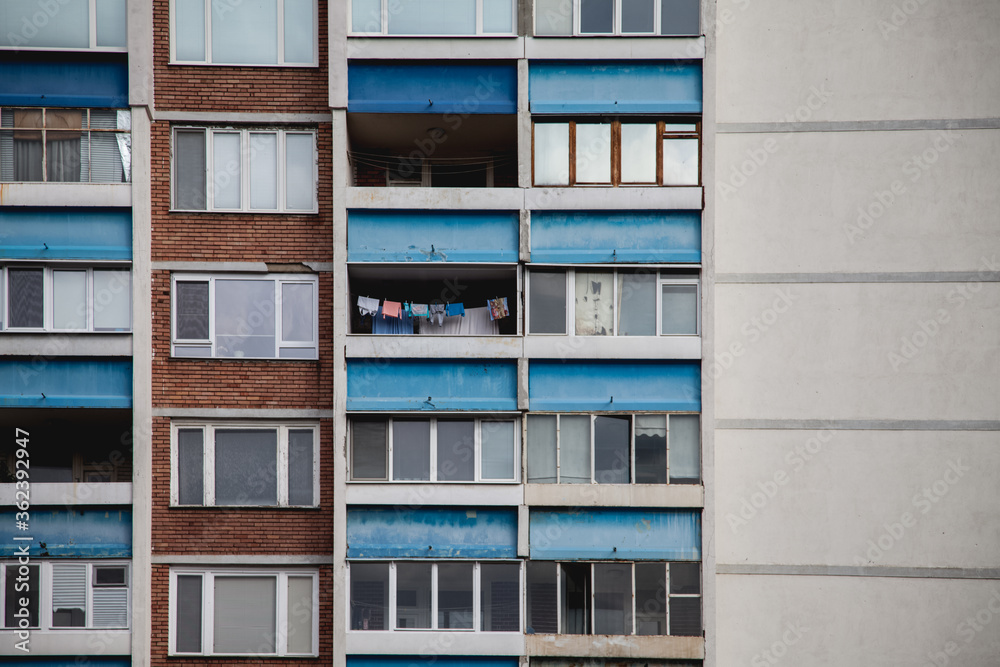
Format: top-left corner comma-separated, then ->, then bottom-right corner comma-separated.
153,0 -> 330,113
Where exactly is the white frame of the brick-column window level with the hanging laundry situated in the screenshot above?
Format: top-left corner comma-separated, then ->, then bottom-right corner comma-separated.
170,273 -> 319,361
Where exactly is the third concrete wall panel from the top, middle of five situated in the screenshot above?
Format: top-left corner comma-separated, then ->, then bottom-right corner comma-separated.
716,282 -> 1000,420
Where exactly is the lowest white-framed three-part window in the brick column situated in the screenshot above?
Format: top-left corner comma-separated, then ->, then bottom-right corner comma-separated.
170,568 -> 319,656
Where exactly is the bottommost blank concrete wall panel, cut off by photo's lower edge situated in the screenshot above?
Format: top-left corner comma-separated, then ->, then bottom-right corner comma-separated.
716,575 -> 1000,667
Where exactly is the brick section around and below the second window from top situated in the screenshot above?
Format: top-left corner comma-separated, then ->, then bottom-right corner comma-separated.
150,122 -> 334,262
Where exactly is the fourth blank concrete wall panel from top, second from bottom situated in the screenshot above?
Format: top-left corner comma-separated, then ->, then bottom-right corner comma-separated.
715,430 -> 1000,568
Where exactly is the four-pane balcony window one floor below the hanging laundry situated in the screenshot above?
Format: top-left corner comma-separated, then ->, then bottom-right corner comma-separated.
351,417 -> 520,483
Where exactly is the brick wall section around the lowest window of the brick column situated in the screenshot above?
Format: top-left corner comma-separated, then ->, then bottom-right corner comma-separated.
150,565 -> 333,667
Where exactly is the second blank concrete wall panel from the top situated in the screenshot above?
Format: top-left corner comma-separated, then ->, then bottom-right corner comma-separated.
715,130 -> 1000,274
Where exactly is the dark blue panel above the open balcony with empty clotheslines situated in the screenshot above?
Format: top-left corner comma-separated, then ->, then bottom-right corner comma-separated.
347,61 -> 517,113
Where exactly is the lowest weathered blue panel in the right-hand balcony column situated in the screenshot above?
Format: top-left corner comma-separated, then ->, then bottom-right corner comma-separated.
528,508 -> 701,560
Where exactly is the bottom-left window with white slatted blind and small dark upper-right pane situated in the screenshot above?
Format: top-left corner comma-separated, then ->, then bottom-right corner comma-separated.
0,560 -> 129,630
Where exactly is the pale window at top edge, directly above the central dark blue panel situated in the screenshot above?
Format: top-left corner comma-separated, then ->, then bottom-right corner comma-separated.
351,0 -> 517,35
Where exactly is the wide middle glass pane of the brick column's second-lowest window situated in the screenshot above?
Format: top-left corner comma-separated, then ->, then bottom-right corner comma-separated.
215,429 -> 278,505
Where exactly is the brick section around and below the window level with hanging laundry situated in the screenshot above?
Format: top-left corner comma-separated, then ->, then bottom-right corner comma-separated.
152,270 -> 333,410
